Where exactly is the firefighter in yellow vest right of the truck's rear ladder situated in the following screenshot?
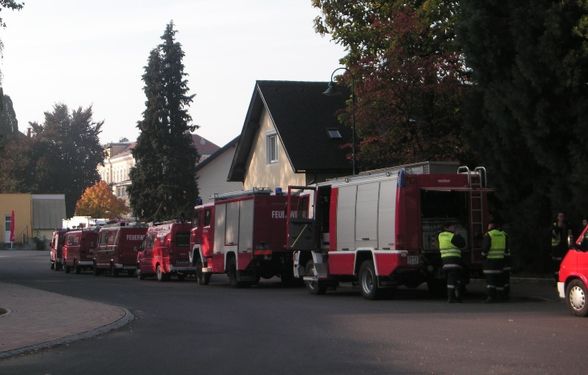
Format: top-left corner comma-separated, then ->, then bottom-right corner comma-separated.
482,220 -> 510,302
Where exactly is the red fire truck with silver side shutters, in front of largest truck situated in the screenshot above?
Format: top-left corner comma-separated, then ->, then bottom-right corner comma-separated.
190,189 -> 293,286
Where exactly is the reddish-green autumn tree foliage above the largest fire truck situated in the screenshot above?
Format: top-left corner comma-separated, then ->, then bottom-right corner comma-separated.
313,0 -> 468,169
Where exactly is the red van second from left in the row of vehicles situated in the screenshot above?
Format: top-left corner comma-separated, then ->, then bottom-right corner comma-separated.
63,229 -> 98,273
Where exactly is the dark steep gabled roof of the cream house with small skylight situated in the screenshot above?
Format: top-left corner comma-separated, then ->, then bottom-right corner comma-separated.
228,81 -> 351,181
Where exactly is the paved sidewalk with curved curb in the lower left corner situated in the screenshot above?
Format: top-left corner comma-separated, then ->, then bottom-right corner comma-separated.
0,283 -> 133,359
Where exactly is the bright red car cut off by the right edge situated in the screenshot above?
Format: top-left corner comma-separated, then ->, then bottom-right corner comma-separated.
557,226 -> 588,316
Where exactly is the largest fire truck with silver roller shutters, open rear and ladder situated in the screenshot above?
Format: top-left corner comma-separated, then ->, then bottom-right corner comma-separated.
287,162 -> 489,299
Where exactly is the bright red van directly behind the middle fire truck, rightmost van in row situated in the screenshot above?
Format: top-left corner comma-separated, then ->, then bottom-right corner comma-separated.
137,222 -> 196,281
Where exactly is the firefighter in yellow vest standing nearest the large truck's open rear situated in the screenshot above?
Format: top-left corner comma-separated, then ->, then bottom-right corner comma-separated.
438,224 -> 465,303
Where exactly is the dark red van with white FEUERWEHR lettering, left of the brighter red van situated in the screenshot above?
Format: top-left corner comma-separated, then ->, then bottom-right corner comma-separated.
94,223 -> 147,276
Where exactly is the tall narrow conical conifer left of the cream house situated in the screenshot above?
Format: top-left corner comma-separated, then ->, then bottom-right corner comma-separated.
129,22 -> 198,220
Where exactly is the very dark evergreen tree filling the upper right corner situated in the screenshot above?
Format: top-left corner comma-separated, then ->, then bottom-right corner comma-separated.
459,0 -> 588,270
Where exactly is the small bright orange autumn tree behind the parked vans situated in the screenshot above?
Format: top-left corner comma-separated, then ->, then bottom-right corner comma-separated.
76,181 -> 129,219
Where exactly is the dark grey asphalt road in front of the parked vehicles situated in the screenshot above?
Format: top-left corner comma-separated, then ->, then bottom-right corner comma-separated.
0,251 -> 588,375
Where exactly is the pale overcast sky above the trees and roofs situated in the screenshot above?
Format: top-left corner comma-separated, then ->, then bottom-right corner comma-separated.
0,0 -> 344,146
